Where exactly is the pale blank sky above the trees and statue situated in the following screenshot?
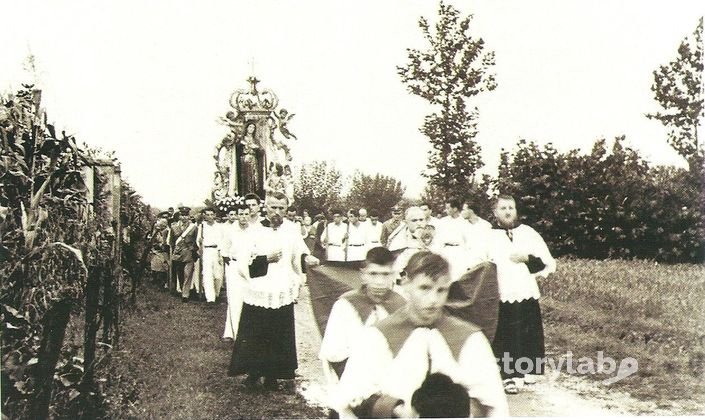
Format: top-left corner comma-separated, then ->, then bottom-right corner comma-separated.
0,0 -> 705,208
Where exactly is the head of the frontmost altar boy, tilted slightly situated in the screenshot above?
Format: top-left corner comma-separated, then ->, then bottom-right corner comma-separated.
403,251 -> 451,326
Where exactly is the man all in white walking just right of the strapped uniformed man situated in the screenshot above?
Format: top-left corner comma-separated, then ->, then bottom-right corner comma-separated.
197,207 -> 223,303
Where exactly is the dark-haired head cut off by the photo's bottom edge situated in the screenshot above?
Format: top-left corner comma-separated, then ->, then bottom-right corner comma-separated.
411,373 -> 470,418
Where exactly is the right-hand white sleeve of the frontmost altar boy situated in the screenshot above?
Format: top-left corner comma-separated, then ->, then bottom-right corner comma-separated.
458,332 -> 509,417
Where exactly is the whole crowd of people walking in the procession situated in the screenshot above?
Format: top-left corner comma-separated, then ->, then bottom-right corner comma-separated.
151,192 -> 556,417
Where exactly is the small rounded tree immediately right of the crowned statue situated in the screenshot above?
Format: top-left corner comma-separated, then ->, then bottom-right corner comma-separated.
294,161 -> 343,214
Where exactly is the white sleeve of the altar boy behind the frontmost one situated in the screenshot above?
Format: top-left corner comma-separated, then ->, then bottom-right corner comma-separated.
318,299 -> 362,363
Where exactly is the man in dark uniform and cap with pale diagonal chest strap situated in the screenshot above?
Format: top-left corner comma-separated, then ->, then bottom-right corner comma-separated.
169,206 -> 198,298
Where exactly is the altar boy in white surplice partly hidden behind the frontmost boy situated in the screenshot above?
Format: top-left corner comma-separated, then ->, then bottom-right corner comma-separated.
318,246 -> 406,385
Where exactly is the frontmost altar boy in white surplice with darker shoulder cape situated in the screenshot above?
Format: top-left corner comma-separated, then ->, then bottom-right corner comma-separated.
336,251 -> 509,418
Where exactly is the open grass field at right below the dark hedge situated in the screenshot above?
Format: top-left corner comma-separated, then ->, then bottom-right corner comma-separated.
540,259 -> 705,406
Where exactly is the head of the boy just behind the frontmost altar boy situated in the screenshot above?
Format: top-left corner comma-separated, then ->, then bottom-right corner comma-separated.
361,246 -> 397,303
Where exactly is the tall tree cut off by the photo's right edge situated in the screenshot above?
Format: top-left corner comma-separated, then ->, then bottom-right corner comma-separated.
646,17 -> 703,163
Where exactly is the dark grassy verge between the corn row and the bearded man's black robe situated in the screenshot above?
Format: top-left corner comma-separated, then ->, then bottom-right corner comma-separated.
102,287 -> 325,419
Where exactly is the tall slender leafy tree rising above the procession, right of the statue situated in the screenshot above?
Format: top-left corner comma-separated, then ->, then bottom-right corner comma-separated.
397,2 -> 497,202
